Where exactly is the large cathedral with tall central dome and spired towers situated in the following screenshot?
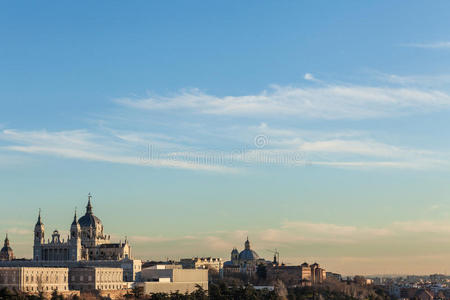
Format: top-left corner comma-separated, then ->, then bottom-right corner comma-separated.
33,194 -> 132,261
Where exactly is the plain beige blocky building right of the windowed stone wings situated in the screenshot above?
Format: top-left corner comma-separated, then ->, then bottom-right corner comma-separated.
136,268 -> 208,295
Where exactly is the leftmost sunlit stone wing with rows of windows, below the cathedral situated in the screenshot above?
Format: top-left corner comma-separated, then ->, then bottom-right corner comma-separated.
0,267 -> 69,293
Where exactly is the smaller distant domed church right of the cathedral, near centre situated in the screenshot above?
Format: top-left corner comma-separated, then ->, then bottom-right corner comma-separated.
224,237 -> 267,276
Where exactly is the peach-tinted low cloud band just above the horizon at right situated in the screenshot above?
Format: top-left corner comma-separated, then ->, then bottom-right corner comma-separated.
126,220 -> 450,263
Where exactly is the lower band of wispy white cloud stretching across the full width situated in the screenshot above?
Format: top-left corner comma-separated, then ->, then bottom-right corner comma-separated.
0,123 -> 442,172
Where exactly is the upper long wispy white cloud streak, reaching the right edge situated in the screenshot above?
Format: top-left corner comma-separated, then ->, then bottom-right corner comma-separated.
116,85 -> 450,120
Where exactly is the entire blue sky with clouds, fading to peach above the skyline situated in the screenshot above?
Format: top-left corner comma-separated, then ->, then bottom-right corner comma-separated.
0,1 -> 450,273
